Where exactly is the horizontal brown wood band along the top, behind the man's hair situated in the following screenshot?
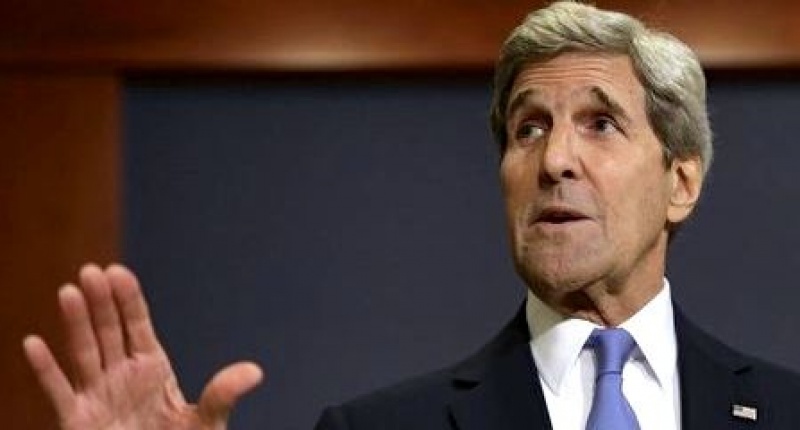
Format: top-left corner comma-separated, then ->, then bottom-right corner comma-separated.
0,0 -> 800,71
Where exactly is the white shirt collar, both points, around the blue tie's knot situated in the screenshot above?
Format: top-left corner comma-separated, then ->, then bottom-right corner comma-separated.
525,278 -> 678,393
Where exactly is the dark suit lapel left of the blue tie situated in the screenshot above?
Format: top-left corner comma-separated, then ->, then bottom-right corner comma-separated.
450,306 -> 552,430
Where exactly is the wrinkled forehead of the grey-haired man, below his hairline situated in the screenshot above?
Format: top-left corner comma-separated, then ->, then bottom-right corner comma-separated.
507,52 -> 644,113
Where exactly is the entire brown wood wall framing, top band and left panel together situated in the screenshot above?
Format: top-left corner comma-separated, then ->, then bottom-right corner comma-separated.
0,0 -> 800,429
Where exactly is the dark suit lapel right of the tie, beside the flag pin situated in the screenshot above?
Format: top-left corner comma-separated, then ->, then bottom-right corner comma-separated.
675,307 -> 758,430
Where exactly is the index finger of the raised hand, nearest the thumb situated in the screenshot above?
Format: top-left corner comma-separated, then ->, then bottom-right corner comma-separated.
106,265 -> 161,354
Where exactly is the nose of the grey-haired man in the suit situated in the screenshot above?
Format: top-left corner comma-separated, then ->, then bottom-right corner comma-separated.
540,125 -> 580,183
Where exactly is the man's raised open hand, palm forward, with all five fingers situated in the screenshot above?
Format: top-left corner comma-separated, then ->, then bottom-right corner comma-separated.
23,265 -> 262,430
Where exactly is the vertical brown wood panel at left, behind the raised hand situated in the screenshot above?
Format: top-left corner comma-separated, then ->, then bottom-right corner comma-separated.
0,72 -> 119,429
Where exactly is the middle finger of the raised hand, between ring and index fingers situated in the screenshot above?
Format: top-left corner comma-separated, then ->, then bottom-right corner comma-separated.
79,264 -> 127,369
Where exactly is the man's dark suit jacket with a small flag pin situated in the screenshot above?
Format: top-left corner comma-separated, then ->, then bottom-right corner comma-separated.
316,307 -> 800,430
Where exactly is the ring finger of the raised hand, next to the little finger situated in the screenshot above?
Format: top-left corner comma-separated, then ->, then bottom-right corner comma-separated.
58,285 -> 103,385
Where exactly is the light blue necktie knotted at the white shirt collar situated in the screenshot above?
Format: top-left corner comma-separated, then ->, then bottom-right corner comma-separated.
586,328 -> 639,430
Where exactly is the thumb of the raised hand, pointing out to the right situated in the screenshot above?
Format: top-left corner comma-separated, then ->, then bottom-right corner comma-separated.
197,362 -> 263,427
